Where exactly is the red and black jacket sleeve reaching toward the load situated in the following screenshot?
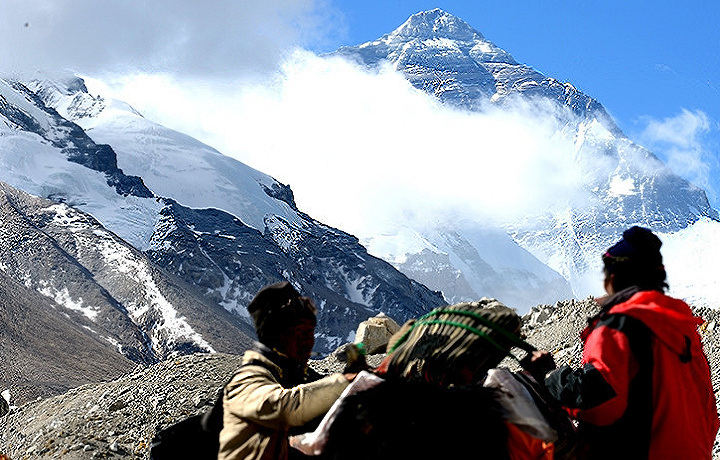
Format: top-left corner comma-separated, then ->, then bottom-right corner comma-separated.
545,325 -> 638,426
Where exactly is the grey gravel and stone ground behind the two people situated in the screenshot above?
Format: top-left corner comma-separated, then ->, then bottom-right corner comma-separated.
0,300 -> 720,460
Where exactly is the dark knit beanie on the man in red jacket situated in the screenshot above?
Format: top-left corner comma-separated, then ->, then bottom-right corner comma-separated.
603,226 -> 663,273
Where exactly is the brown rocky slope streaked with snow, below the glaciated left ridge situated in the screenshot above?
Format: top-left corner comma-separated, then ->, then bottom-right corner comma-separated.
0,182 -> 254,367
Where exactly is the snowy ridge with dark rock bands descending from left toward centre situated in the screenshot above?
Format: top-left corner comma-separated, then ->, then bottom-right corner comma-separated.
0,72 -> 444,361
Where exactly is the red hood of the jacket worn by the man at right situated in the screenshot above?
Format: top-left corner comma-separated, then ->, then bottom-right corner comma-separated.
610,291 -> 705,359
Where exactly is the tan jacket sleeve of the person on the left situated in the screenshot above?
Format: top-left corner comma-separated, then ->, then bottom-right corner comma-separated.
224,366 -> 348,429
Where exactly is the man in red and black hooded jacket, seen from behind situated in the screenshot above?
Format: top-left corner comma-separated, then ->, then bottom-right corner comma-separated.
545,227 -> 719,459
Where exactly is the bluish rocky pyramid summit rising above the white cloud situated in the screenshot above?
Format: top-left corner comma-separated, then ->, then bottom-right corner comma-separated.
333,9 -> 622,129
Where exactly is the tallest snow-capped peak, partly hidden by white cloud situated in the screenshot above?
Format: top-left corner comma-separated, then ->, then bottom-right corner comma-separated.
335,9 -> 718,310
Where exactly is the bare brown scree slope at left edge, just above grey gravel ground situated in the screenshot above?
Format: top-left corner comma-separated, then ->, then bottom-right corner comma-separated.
0,271 -> 135,406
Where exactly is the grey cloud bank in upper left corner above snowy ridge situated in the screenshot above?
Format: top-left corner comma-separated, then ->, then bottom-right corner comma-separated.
0,0 -> 341,78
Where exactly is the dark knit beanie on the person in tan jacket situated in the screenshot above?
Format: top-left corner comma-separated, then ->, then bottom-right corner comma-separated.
247,281 -> 317,346
